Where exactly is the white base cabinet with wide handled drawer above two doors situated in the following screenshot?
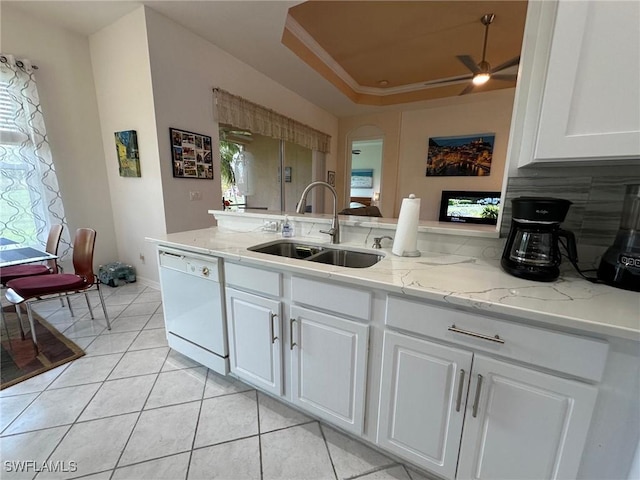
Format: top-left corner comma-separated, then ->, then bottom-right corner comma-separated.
377,295 -> 609,480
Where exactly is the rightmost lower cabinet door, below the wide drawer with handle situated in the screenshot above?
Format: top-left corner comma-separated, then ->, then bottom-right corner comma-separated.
458,355 -> 597,480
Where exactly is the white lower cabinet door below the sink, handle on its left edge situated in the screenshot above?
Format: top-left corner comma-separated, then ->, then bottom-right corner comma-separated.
290,306 -> 369,435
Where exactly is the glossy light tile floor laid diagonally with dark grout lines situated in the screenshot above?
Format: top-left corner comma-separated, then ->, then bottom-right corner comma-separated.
0,283 -> 432,480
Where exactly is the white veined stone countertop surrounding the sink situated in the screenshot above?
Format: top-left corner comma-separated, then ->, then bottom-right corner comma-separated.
147,227 -> 640,341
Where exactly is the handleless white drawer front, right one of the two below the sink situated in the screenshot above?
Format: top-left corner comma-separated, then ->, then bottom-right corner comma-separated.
291,277 -> 371,320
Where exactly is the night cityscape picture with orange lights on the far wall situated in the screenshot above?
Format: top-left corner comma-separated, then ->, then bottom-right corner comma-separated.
426,133 -> 495,177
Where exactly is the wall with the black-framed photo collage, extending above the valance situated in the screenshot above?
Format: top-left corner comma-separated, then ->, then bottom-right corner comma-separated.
143,8 -> 338,232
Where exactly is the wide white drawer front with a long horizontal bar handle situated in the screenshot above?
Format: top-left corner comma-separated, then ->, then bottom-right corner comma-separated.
385,295 -> 609,382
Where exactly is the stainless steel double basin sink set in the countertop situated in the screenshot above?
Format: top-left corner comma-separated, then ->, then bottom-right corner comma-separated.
247,240 -> 384,268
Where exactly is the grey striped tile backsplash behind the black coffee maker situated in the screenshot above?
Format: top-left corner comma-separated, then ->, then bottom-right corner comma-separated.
500,175 -> 640,260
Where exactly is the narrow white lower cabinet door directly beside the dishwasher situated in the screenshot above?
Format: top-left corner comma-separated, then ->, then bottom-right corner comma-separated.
226,288 -> 282,395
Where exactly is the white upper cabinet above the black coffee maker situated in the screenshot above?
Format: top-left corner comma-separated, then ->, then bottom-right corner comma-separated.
512,0 -> 640,167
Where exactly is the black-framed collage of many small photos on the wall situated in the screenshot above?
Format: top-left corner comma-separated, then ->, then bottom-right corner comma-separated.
169,128 -> 213,180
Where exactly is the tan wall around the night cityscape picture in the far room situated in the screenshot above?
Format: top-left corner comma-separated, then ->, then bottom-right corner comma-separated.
396,89 -> 515,220
